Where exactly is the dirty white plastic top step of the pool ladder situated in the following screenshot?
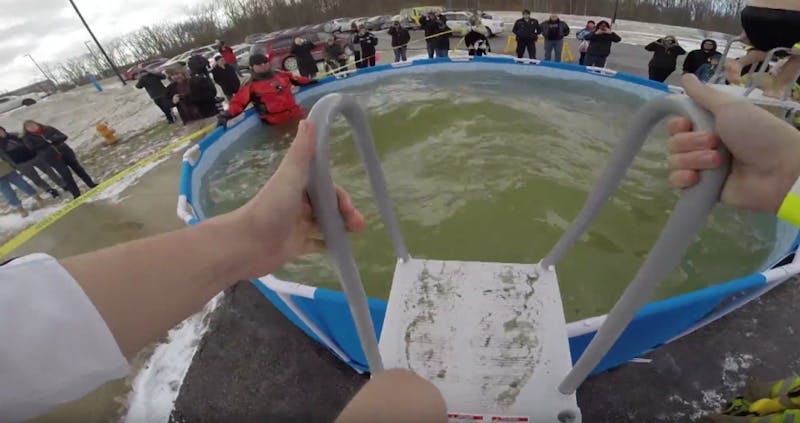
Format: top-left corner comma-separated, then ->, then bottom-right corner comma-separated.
380,259 -> 580,423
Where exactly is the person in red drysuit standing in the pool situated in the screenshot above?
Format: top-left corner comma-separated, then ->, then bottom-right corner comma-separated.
218,54 -> 315,126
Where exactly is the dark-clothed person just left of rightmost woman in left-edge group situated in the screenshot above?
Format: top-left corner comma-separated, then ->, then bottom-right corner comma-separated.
0,127 -> 64,198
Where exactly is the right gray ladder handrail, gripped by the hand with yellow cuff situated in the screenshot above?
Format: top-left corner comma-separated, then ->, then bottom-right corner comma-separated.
542,95 -> 730,395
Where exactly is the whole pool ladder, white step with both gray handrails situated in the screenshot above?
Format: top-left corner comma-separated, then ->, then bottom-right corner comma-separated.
309,94 -> 730,422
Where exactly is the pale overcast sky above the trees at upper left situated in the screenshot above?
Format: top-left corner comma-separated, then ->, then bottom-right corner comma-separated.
0,0 -> 201,92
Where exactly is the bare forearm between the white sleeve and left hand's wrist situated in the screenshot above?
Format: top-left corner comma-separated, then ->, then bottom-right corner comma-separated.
62,210 -> 260,358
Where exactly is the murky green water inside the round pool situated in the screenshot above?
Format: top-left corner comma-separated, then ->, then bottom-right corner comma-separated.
202,74 -> 775,320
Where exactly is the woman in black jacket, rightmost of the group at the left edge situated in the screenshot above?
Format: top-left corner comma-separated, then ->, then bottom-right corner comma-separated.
22,120 -> 97,198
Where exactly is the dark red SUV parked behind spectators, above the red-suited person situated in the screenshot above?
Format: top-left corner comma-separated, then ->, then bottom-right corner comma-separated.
250,30 -> 348,72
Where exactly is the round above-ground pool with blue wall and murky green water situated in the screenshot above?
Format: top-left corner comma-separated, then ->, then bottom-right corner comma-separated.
179,58 -> 797,378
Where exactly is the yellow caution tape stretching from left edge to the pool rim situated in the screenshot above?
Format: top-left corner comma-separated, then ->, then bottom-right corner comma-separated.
0,125 -> 214,257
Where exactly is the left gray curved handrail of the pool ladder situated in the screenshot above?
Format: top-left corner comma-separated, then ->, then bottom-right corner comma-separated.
308,94 -> 409,375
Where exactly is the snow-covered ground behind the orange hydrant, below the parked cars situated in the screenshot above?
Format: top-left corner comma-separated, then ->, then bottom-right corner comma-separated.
0,79 -> 164,148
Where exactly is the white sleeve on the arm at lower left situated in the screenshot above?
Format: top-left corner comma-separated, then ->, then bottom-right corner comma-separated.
0,254 -> 129,422
